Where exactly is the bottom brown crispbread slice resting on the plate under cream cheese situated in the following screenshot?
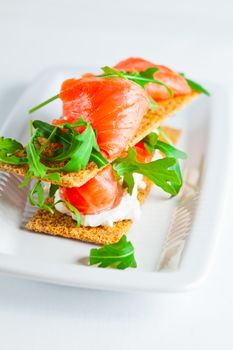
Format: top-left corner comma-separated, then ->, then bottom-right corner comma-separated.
26,127 -> 181,244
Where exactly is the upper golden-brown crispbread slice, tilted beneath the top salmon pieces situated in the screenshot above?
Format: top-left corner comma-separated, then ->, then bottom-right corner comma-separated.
0,92 -> 199,187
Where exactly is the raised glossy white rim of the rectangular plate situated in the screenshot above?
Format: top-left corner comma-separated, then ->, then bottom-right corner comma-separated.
0,66 -> 233,292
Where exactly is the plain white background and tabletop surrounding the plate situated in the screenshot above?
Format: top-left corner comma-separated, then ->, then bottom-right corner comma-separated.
0,0 -> 233,350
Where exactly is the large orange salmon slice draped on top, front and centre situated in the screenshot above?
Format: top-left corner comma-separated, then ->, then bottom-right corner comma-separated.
53,77 -> 150,160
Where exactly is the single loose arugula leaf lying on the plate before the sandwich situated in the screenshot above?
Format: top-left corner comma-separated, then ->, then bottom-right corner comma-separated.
89,235 -> 137,270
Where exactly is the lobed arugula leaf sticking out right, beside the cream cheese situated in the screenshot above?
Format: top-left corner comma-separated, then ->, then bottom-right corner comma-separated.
113,148 -> 182,195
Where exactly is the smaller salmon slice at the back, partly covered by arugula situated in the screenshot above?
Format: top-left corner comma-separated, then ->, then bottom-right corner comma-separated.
114,57 -> 191,101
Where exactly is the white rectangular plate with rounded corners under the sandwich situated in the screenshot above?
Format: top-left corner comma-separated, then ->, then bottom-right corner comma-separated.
0,67 -> 231,292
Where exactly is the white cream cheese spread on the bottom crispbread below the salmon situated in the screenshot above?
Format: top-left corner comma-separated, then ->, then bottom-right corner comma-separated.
55,174 -> 146,227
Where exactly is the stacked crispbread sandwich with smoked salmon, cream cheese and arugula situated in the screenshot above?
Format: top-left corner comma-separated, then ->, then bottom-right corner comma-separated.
0,58 -> 208,266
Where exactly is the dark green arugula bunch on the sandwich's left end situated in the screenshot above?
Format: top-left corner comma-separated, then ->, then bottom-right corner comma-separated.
0,117 -> 108,216
